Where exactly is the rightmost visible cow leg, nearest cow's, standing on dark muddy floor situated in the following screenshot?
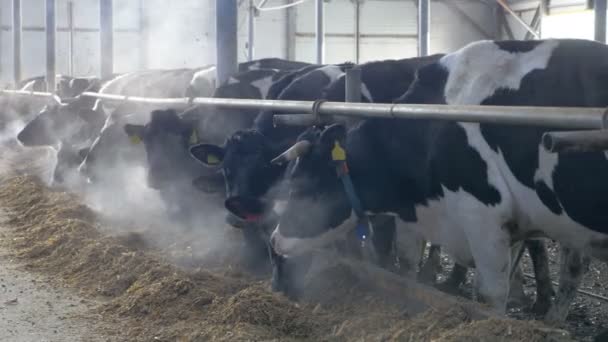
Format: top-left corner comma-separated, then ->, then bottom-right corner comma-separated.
545,246 -> 591,323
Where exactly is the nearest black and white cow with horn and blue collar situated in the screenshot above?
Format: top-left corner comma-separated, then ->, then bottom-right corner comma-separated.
271,40 -> 608,320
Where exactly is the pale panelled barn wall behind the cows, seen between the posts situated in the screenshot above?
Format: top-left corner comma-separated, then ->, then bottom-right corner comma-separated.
0,0 -> 495,84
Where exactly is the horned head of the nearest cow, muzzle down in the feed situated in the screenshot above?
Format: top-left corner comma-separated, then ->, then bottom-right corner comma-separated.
271,124 -> 352,255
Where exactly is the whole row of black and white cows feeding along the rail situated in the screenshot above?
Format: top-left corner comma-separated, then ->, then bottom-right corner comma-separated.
5,40 -> 608,332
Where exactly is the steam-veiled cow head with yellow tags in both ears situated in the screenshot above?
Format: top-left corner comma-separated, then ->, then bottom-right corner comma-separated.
124,109 -> 223,190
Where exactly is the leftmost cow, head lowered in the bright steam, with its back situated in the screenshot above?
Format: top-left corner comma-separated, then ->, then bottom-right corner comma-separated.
17,67 -> 213,184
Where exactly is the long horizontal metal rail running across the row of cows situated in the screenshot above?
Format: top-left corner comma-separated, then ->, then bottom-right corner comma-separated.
0,90 -> 608,152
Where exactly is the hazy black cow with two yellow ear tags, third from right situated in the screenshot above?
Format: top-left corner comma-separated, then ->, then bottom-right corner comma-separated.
124,69 -> 286,270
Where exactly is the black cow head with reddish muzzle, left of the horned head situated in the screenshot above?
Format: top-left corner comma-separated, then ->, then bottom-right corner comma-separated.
190,130 -> 294,225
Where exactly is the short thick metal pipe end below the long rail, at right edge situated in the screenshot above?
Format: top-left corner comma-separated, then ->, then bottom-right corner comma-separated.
542,129 -> 608,153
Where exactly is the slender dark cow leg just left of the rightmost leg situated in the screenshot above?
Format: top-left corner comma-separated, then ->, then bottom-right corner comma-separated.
526,240 -> 555,315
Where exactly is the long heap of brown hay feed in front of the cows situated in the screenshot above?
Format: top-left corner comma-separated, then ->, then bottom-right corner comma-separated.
0,176 -> 580,342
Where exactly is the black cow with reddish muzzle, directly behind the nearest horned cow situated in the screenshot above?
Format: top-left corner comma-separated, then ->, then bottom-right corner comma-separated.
191,55 -> 480,297
